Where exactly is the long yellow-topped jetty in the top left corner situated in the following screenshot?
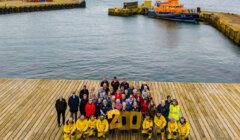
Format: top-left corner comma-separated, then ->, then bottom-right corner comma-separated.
0,0 -> 86,15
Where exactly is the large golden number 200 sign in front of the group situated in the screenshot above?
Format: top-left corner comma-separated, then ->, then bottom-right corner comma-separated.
107,109 -> 142,130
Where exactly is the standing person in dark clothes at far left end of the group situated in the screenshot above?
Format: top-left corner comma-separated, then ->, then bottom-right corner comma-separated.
55,96 -> 67,127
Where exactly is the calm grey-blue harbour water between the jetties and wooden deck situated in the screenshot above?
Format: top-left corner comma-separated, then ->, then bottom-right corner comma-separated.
0,0 -> 240,82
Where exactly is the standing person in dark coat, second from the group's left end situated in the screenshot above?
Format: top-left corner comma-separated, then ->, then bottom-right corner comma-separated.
68,92 -> 79,121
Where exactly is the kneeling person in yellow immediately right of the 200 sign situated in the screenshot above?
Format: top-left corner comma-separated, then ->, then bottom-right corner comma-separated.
142,114 -> 153,139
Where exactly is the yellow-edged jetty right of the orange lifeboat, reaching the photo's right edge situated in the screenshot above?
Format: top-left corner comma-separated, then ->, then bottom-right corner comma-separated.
200,11 -> 240,46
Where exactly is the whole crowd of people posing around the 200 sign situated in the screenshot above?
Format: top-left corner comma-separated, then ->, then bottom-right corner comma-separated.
55,77 -> 190,140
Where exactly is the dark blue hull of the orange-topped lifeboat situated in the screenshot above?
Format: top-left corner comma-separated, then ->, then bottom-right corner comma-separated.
148,11 -> 199,23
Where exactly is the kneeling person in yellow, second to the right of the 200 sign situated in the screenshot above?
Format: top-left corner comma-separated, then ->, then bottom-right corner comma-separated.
154,111 -> 167,139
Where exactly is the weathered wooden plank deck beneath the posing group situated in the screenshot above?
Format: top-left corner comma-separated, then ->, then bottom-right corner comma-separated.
0,79 -> 240,140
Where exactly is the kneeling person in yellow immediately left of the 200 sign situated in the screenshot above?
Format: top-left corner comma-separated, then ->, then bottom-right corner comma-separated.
96,115 -> 109,138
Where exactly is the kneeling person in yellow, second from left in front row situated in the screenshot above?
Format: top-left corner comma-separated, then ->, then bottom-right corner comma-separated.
75,115 -> 88,139
